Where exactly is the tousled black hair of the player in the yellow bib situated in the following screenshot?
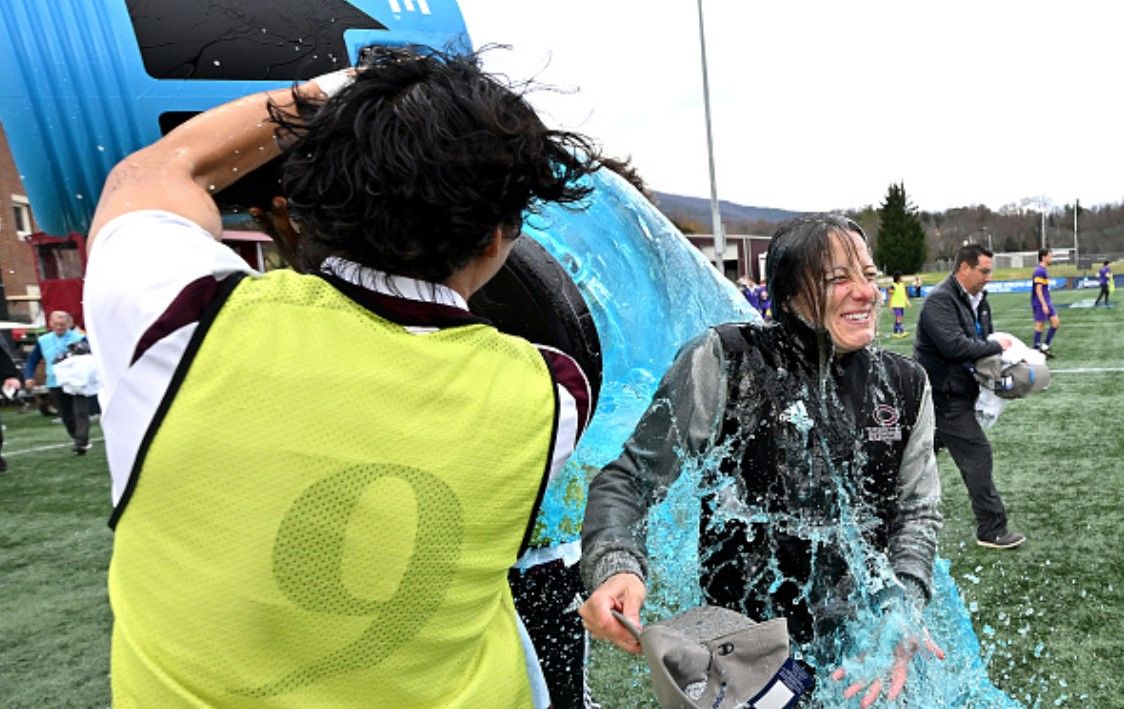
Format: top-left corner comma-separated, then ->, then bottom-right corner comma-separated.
270,46 -> 599,282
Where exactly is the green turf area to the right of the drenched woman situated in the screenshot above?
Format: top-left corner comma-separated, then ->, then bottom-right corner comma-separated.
881,290 -> 1124,707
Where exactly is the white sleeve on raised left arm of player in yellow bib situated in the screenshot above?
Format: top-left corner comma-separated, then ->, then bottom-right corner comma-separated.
83,210 -> 254,400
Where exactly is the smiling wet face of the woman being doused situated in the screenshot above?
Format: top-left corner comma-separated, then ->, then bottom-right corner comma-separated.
823,231 -> 880,353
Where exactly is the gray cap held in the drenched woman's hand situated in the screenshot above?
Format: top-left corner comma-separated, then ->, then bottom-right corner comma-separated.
613,606 -> 810,709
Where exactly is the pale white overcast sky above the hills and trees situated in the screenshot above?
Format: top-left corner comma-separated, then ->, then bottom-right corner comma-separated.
460,0 -> 1124,216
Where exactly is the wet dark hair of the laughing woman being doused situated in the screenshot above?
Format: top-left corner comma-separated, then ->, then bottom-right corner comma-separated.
765,215 -> 867,328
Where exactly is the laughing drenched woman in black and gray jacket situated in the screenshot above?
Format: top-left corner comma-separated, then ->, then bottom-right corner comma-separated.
581,215 -> 943,706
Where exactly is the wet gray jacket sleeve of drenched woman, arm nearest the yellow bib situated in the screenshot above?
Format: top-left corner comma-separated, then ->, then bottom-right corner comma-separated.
581,330 -> 726,591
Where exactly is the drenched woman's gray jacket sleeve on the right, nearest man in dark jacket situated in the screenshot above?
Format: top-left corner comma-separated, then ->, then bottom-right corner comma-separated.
889,381 -> 944,601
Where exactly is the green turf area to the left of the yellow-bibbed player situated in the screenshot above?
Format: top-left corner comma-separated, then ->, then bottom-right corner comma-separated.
0,406 -> 112,707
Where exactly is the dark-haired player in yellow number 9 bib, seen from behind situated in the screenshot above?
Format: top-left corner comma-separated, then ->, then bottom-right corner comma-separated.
85,47 -> 599,707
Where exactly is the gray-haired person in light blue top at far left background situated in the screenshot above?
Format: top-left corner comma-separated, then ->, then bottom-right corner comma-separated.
24,310 -> 93,455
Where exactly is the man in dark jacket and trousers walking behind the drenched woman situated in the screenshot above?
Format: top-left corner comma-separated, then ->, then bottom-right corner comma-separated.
914,244 -> 1026,549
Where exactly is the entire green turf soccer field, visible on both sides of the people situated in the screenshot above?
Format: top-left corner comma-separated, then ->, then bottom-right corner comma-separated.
0,291 -> 1124,709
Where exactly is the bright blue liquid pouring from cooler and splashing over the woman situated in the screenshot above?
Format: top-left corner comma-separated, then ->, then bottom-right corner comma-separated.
525,171 -> 1019,707
